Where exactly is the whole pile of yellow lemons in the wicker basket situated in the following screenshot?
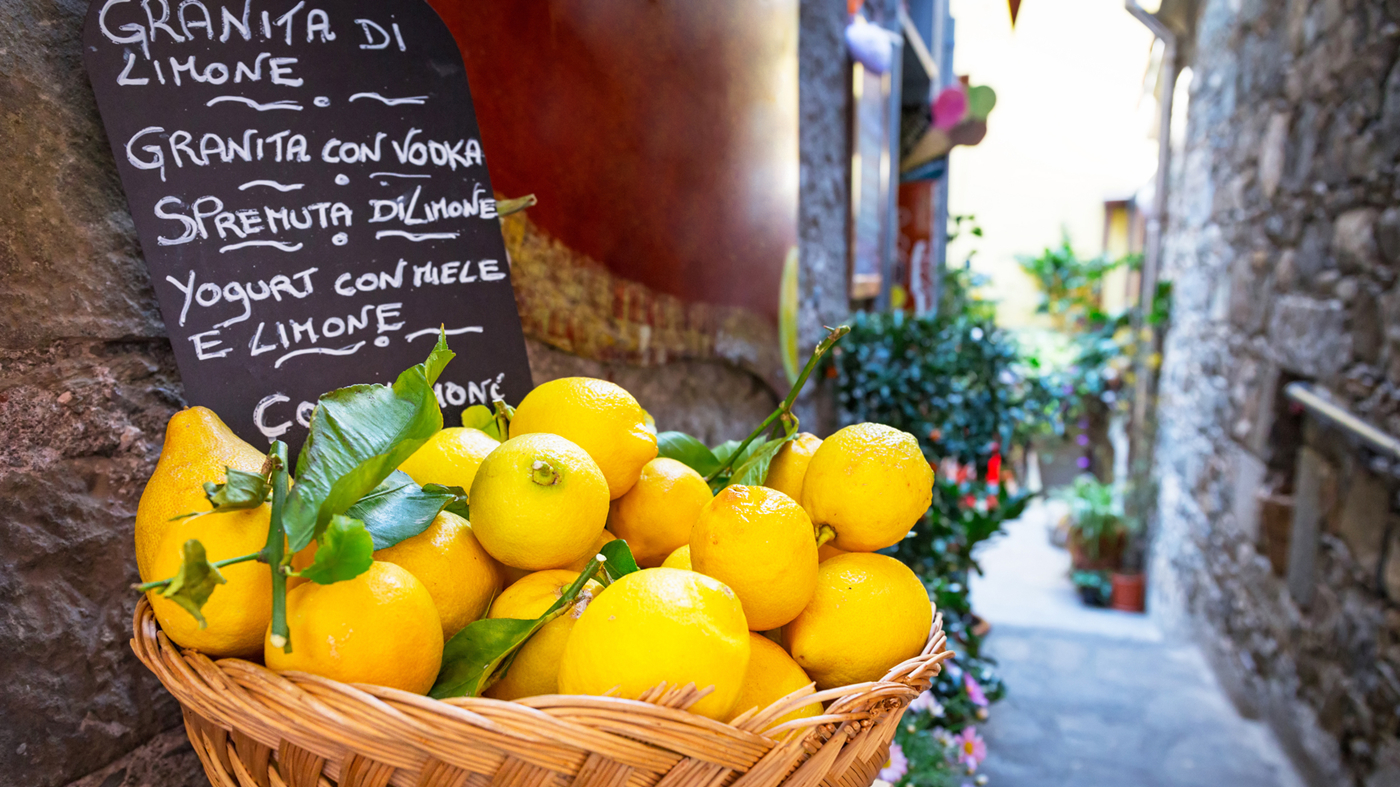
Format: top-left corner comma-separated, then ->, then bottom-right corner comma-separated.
136,378 -> 932,720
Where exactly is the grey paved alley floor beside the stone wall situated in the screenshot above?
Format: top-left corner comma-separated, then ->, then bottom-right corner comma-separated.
972,504 -> 1302,787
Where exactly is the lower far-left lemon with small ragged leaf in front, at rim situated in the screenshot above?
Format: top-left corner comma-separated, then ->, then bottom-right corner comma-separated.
150,504 -> 272,658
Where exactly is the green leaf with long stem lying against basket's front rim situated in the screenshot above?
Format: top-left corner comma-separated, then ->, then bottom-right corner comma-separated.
428,557 -> 599,691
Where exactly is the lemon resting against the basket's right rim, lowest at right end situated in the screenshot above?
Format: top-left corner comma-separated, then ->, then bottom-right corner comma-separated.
783,552 -> 934,689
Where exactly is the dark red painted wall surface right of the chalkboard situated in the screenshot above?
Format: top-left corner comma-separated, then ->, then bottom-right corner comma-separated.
431,0 -> 798,315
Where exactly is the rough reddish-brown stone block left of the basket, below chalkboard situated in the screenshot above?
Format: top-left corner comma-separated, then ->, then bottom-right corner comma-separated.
0,342 -> 179,787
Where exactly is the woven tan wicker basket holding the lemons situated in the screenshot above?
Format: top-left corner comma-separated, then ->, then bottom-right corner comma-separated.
132,598 -> 951,787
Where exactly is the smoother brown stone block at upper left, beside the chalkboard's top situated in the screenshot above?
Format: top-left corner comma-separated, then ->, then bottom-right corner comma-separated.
0,0 -> 165,347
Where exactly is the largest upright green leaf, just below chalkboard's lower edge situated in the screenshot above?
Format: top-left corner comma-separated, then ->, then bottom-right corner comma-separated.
286,333 -> 454,552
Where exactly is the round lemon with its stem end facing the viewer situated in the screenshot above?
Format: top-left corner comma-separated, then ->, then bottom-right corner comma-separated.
470,434 -> 608,570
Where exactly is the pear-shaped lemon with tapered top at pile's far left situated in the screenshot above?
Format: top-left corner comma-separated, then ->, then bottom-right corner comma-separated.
136,408 -> 272,583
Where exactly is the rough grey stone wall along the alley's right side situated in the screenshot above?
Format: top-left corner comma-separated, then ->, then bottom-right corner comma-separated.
1149,0 -> 1400,786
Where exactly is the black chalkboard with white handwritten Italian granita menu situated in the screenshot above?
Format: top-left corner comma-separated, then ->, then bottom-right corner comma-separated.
83,0 -> 531,451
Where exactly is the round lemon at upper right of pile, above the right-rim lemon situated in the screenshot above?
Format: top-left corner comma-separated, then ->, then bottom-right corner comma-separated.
802,423 -> 934,552
